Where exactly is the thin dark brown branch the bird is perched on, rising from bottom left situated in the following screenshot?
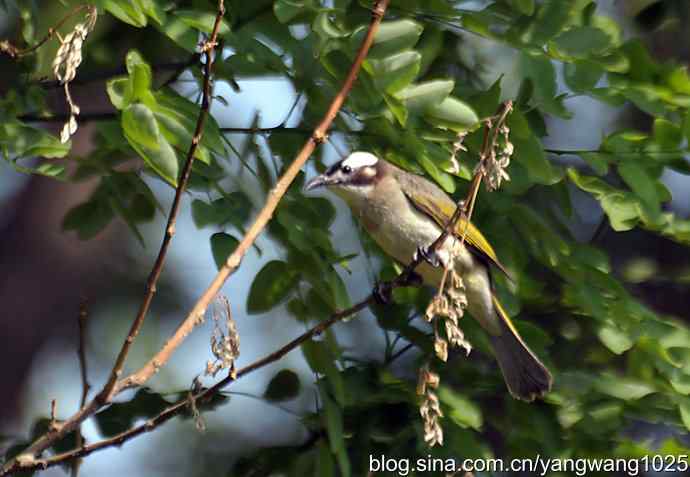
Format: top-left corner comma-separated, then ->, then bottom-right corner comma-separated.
0,102 -> 512,475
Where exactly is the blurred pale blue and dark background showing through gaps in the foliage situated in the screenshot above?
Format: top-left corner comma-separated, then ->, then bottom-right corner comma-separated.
0,0 -> 690,476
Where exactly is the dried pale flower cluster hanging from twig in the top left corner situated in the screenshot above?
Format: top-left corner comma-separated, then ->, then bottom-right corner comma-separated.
53,7 -> 98,143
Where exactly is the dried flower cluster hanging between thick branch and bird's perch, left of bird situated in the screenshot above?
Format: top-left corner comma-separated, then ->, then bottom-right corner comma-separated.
205,295 -> 240,377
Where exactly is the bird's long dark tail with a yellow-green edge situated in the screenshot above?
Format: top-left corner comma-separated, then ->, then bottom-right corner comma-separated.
491,296 -> 553,401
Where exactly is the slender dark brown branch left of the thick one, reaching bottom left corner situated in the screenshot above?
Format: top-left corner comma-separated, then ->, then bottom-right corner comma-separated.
0,0 -> 225,475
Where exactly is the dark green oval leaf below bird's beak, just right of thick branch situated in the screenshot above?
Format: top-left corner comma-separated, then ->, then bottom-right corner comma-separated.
247,260 -> 299,314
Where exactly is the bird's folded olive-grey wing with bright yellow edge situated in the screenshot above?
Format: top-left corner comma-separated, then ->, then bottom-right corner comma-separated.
398,174 -> 510,278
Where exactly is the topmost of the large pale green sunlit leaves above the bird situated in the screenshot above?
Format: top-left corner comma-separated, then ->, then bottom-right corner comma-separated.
350,19 -> 424,60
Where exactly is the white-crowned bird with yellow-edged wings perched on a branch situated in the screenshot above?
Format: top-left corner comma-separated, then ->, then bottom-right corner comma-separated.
305,151 -> 553,402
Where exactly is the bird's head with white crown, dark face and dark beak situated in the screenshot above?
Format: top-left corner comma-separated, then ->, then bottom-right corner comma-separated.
306,151 -> 384,192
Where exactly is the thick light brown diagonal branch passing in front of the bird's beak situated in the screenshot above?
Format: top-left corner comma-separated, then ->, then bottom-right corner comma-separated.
114,0 -> 390,393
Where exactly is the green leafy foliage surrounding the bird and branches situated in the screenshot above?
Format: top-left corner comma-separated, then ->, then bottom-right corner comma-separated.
0,0 -> 690,476
